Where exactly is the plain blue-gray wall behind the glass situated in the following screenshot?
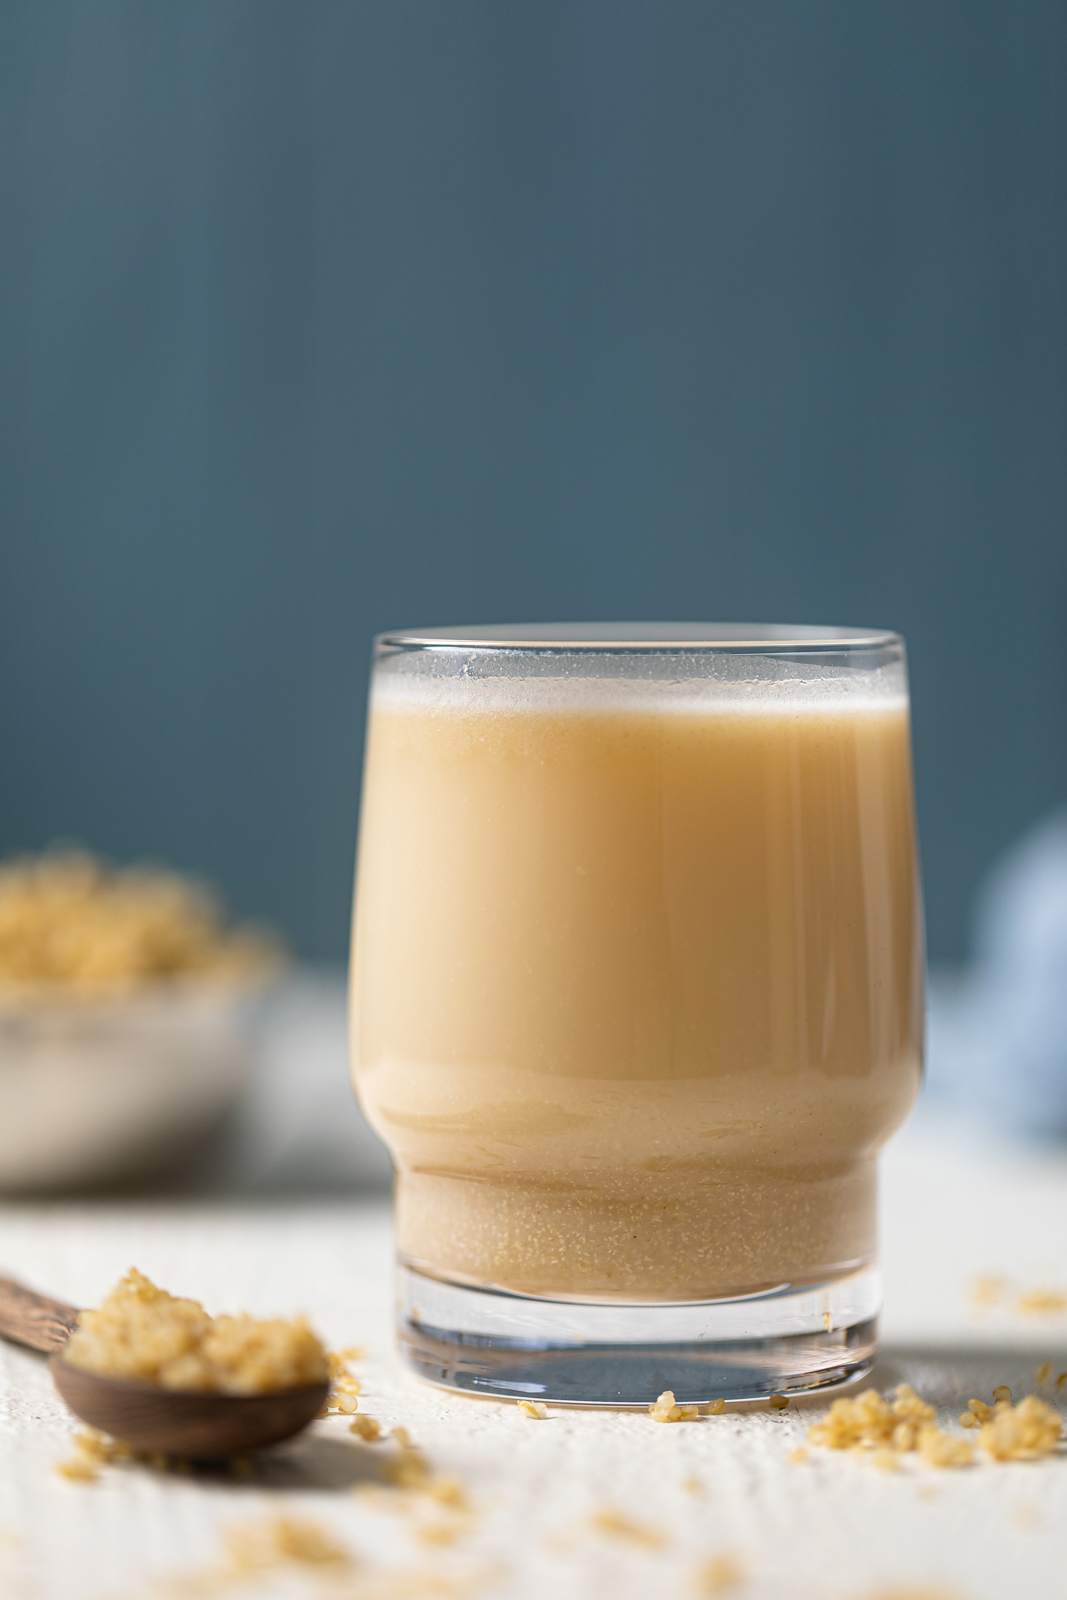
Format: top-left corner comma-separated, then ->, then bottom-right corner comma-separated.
0,0 -> 1067,958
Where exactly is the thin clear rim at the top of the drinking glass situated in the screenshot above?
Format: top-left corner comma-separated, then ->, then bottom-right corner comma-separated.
374,622 -> 904,654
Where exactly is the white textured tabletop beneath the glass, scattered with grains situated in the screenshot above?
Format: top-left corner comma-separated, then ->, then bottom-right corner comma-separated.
0,1120 -> 1067,1600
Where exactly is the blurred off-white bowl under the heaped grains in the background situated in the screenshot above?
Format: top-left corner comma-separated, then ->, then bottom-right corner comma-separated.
0,984 -> 250,1190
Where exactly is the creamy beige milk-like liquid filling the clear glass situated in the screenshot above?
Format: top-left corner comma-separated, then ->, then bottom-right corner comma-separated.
354,685 -> 921,1301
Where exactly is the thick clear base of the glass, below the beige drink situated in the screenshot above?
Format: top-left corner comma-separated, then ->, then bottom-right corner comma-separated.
397,1261 -> 881,1406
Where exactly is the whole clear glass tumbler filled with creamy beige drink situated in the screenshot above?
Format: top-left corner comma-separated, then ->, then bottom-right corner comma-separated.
352,624 -> 923,1405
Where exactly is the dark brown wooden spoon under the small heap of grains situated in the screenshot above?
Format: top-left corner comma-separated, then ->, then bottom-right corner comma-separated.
0,1278 -> 330,1461
